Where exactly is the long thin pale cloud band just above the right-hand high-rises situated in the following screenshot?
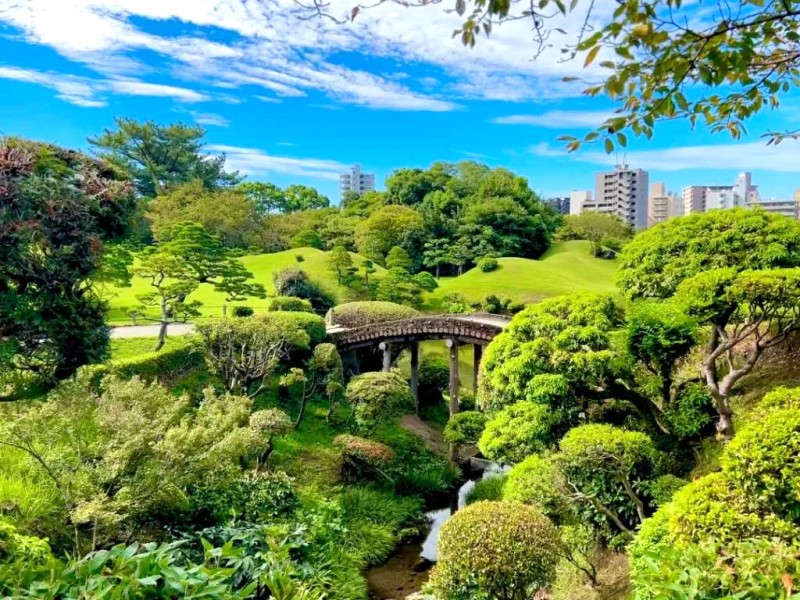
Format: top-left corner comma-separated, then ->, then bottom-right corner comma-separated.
530,140 -> 800,173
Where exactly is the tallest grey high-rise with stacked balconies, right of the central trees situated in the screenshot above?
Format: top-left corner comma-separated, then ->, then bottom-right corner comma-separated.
584,165 -> 650,229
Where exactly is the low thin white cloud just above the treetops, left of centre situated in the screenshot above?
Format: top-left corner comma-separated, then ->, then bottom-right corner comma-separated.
208,144 -> 349,181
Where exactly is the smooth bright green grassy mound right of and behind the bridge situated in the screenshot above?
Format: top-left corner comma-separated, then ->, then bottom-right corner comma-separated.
426,241 -> 616,311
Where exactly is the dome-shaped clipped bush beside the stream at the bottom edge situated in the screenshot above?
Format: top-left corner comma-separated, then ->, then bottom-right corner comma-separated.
430,502 -> 560,600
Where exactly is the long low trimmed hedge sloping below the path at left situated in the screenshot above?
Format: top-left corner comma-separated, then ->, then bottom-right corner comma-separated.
80,345 -> 204,386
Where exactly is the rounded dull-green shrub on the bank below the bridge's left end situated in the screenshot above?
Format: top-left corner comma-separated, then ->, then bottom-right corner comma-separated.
345,372 -> 414,435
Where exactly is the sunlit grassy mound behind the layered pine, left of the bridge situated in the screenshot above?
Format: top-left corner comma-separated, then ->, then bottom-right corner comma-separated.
104,248 -> 383,324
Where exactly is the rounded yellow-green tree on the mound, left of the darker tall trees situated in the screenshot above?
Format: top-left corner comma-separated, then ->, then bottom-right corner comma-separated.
356,206 -> 423,263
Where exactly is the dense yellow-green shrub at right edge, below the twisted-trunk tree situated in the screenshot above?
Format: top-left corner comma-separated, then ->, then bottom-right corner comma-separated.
720,408 -> 800,524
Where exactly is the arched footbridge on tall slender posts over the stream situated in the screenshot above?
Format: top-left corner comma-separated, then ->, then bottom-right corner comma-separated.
328,313 -> 510,414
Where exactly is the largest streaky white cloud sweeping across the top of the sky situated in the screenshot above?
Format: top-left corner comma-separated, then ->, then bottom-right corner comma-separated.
0,0 -> 615,111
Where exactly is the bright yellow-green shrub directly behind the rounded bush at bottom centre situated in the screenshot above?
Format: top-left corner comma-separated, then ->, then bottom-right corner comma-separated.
503,455 -> 569,522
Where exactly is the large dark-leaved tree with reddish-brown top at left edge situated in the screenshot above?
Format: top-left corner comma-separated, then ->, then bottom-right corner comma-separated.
0,138 -> 135,397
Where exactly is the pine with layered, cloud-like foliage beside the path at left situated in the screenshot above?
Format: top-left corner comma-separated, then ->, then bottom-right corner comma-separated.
133,223 -> 266,351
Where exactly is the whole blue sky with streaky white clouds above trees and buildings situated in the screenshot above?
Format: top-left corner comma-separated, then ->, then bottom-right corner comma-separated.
0,0 -> 800,201
